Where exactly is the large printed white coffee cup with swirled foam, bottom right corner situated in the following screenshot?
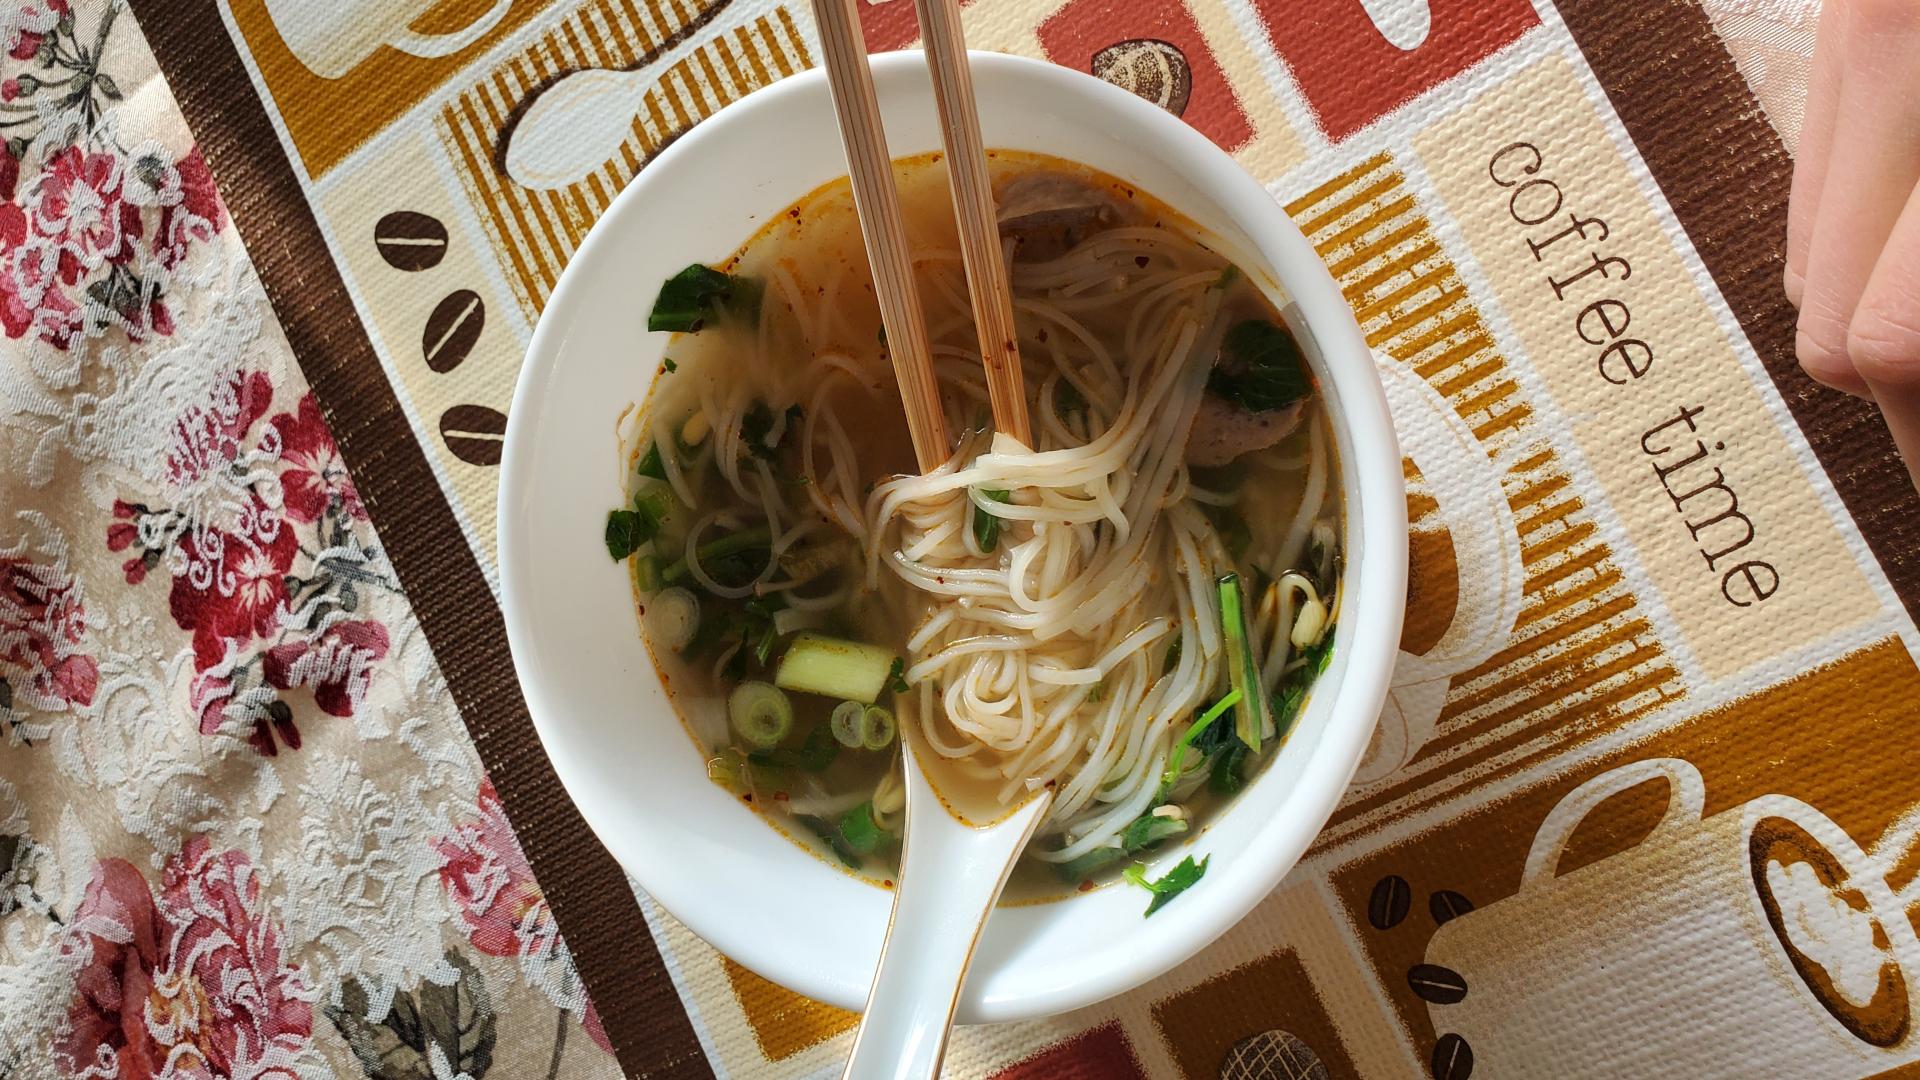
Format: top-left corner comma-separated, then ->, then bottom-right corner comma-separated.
1427,757 -> 1920,1078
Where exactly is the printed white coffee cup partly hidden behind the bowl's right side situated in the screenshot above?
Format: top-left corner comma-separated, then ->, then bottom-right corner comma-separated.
1354,356 -> 1526,784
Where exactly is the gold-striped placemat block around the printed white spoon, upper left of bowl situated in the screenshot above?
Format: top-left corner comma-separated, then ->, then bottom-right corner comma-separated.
434,0 -> 812,319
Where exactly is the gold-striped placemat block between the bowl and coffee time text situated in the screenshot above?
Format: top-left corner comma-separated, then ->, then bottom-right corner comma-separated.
1286,154 -> 1686,847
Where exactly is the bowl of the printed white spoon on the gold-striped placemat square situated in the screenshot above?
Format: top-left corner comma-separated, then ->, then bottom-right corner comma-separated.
507,67 -> 653,188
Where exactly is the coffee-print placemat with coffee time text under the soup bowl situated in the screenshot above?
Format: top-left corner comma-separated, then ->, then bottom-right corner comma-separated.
116,0 -> 1920,1080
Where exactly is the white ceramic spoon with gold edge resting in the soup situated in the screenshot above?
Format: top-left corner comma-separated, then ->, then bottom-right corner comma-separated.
845,749 -> 1054,1080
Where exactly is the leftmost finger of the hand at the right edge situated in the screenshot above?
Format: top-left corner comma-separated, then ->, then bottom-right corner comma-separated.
1799,0 -> 1920,392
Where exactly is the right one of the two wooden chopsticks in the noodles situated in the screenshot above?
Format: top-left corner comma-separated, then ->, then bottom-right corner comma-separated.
914,0 -> 1033,446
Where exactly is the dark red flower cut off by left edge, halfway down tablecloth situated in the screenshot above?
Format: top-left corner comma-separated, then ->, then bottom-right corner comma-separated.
0,559 -> 100,705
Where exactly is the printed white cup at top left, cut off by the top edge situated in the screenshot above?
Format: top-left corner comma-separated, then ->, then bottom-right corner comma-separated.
267,0 -> 513,79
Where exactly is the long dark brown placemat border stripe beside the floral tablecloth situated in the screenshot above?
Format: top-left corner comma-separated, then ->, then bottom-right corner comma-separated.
132,0 -> 712,1076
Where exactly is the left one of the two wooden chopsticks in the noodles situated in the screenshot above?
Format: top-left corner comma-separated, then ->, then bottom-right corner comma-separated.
814,0 -> 952,473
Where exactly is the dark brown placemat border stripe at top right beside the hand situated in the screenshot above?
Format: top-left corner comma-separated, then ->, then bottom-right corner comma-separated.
1555,0 -> 1920,619
